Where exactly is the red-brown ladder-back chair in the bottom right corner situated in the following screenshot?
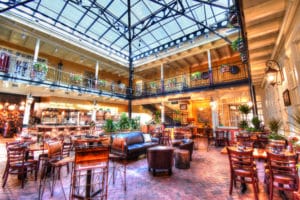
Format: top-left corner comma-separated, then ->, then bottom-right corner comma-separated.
265,152 -> 299,200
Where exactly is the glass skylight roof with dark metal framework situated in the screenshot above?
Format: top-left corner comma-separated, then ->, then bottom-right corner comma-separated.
0,0 -> 233,64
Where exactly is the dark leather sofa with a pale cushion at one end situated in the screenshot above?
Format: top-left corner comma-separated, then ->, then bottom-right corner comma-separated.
111,131 -> 159,159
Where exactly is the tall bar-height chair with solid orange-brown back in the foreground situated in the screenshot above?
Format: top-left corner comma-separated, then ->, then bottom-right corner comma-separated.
70,146 -> 109,199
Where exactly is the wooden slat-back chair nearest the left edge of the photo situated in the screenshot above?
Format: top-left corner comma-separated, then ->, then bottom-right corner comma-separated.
2,145 -> 38,188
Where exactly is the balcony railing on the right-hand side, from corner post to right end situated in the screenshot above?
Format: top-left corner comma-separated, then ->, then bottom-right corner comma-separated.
134,64 -> 248,97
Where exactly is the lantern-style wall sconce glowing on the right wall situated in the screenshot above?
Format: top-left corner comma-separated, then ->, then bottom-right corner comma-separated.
266,60 -> 284,86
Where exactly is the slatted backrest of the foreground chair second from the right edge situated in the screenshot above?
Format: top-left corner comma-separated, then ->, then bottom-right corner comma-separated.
227,147 -> 254,175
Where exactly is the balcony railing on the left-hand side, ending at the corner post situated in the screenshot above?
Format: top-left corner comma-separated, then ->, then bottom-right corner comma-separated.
0,52 -> 127,97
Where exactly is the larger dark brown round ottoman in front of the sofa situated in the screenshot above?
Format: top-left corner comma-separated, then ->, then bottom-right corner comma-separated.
147,146 -> 174,176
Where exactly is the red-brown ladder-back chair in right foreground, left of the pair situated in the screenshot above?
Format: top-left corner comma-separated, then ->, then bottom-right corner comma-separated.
227,147 -> 258,200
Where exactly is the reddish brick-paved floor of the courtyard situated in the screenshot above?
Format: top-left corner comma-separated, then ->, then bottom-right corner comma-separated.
0,138 -> 291,200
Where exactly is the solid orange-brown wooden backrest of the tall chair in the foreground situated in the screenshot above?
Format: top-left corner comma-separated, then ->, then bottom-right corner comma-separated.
75,146 -> 109,166
